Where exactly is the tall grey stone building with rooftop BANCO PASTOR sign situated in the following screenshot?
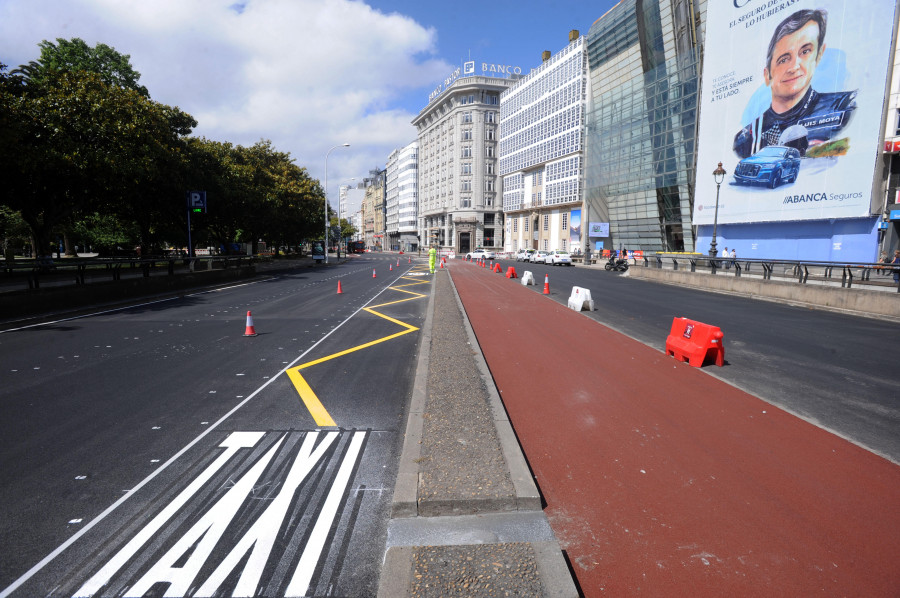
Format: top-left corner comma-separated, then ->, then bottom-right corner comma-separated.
412,76 -> 514,254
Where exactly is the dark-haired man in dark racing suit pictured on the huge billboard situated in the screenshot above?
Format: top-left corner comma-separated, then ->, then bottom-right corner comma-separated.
734,9 -> 856,158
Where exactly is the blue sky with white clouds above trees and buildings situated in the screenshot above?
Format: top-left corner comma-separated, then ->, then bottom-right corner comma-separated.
0,0 -> 616,205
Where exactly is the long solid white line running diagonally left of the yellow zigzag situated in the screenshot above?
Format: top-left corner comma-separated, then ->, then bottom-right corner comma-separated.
0,276 -> 400,598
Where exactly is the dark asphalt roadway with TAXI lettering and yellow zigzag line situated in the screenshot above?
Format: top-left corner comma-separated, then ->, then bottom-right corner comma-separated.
0,256 -> 431,597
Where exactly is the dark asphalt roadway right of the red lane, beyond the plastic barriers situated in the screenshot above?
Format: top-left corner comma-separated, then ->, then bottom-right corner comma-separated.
497,260 -> 900,463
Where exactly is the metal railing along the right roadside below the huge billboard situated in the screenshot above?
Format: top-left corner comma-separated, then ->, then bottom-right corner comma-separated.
643,254 -> 900,293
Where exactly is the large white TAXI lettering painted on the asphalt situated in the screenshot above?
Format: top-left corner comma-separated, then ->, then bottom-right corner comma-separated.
72,430 -> 368,598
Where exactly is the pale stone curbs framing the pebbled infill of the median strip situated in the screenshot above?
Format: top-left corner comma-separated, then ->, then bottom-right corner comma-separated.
378,271 -> 578,598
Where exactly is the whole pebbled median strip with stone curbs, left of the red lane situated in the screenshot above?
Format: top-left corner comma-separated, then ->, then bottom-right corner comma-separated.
378,269 -> 578,598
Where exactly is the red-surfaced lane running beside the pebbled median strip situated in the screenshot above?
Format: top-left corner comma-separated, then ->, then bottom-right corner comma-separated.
450,262 -> 900,596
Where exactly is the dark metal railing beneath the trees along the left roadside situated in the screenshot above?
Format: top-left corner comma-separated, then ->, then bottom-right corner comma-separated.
0,256 -> 260,290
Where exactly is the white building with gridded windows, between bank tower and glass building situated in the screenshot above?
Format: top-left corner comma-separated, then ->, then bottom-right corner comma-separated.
500,31 -> 587,252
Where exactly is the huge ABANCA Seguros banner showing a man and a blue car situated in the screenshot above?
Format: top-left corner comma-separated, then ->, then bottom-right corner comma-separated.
693,0 -> 896,224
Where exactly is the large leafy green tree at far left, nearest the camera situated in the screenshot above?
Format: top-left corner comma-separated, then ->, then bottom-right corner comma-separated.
0,72 -> 196,254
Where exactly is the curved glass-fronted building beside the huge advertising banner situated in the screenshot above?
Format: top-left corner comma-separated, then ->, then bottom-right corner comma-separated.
584,0 -> 706,251
